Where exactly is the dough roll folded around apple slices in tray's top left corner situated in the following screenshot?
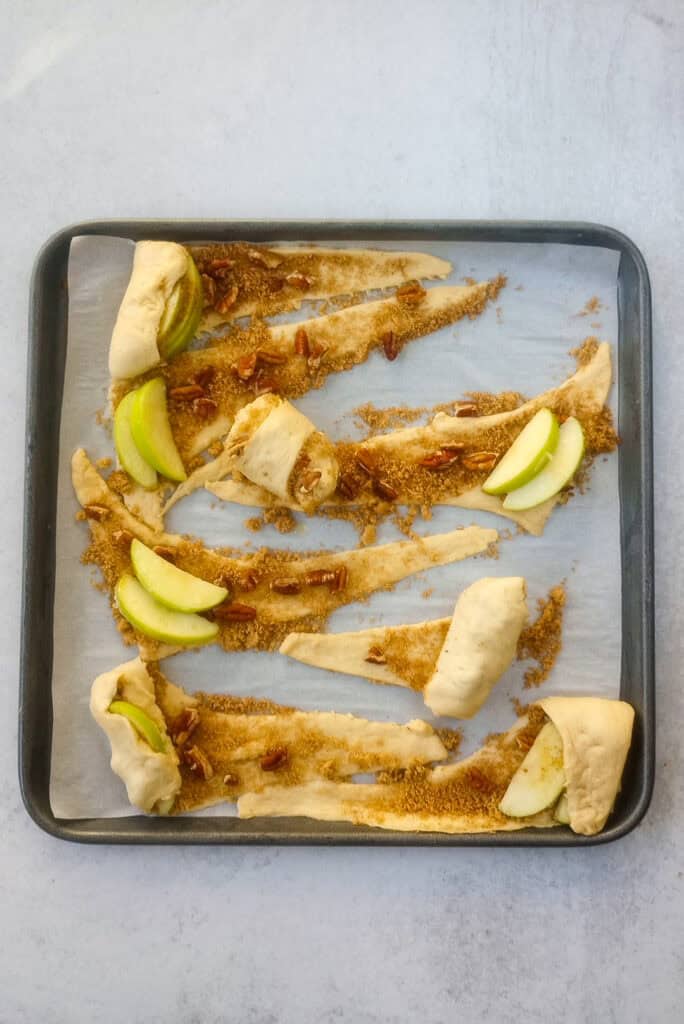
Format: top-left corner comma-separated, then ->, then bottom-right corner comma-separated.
110,242 -> 203,380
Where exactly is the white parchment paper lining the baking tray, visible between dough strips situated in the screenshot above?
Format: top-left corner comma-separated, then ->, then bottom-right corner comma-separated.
50,237 -> 621,817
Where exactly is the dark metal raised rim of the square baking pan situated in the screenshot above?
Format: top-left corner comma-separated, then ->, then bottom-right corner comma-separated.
18,219 -> 655,847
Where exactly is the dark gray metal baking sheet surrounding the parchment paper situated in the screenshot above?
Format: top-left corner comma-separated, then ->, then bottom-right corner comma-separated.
20,222 -> 653,846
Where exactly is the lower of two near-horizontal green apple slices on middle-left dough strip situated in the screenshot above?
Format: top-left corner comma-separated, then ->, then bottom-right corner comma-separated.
116,575 -> 218,646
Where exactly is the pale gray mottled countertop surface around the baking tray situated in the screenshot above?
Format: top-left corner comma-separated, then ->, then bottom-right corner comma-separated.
0,0 -> 684,1024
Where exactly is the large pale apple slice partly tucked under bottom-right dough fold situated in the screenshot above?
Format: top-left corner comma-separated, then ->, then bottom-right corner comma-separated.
499,722 -> 565,818
